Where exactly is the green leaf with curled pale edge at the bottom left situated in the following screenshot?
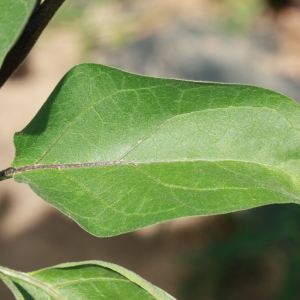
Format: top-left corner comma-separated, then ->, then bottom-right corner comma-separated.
0,261 -> 174,300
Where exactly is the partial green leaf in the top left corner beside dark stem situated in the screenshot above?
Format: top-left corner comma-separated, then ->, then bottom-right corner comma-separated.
0,0 -> 36,67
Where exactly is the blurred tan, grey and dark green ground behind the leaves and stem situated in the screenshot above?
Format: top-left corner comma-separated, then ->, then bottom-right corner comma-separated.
0,0 -> 300,300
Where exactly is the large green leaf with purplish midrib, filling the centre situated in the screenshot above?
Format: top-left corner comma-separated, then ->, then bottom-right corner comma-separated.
5,64 -> 300,236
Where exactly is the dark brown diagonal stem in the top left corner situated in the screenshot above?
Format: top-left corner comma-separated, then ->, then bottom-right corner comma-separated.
0,0 -> 65,88
